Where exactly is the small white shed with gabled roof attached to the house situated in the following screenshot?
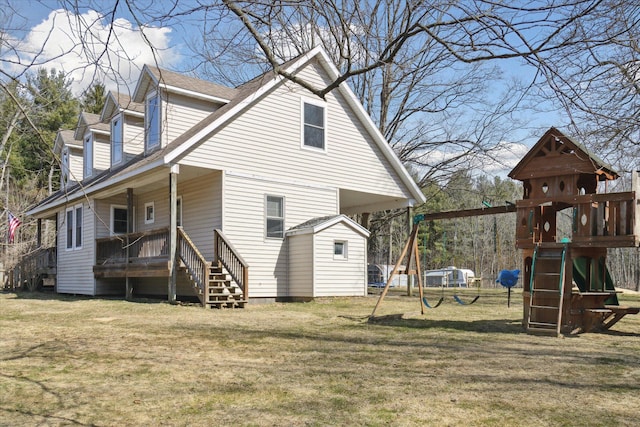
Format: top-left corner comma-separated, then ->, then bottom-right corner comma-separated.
286,215 -> 369,298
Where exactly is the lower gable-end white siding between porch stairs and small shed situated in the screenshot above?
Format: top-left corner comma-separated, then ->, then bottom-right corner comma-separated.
222,172 -> 338,297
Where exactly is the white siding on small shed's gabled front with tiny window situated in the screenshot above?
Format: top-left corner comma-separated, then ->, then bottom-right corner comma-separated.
313,223 -> 367,297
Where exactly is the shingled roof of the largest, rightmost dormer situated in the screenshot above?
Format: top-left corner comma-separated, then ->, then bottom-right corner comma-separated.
132,65 -> 236,104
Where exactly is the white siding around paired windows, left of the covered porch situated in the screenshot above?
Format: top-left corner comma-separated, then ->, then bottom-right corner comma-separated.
56,202 -> 95,295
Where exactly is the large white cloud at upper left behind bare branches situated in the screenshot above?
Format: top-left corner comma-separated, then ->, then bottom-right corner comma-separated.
0,9 -> 181,95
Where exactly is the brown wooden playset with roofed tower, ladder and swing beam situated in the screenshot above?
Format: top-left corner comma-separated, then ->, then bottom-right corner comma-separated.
371,128 -> 640,335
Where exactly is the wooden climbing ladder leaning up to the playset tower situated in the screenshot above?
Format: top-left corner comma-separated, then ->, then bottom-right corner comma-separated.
527,244 -> 567,336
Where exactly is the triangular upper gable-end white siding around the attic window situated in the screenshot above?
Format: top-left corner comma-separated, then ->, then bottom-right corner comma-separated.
181,60 -> 411,206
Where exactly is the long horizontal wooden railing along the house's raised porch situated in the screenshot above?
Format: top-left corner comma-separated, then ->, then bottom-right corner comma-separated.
96,228 -> 169,265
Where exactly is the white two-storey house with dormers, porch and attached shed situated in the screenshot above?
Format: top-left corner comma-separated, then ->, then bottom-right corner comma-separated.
28,48 -> 424,306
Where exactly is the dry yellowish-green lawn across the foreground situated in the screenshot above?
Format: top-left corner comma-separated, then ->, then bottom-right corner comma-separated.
0,290 -> 640,426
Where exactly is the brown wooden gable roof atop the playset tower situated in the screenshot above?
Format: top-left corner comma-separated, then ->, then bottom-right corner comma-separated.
509,127 -> 619,181
